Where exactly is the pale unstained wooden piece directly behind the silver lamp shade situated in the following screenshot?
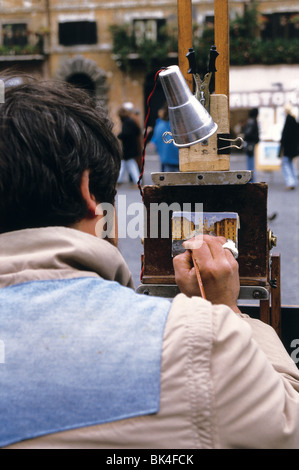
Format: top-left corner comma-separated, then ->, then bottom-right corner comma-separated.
179,95 -> 230,171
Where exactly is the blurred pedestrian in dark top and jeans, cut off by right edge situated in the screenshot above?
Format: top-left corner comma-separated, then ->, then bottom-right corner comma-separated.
279,103 -> 299,190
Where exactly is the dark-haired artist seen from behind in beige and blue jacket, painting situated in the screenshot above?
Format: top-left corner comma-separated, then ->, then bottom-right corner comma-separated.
0,76 -> 299,449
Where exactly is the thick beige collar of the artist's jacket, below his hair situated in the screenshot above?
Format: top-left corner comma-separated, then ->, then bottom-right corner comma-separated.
0,227 -> 133,287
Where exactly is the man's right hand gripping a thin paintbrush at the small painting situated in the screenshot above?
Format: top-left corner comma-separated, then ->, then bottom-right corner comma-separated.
173,235 -> 240,313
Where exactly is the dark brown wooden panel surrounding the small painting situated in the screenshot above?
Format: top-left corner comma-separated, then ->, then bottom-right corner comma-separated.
142,183 -> 269,286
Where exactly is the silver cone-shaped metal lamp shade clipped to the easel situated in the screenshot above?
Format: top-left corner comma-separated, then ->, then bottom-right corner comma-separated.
159,65 -> 218,147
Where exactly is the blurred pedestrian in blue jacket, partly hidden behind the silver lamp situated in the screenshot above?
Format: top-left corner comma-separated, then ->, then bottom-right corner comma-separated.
151,104 -> 180,172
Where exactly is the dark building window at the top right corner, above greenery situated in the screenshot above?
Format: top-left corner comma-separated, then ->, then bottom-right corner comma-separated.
261,12 -> 299,39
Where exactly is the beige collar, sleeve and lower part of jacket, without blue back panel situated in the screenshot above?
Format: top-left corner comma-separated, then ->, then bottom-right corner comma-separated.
0,227 -> 299,449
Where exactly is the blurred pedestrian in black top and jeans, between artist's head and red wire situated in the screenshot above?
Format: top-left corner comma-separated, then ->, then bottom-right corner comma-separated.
117,103 -> 141,184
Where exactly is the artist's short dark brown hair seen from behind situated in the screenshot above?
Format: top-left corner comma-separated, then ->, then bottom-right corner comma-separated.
0,77 -> 121,233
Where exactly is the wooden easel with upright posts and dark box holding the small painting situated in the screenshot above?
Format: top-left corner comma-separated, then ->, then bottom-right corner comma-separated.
138,0 -> 281,335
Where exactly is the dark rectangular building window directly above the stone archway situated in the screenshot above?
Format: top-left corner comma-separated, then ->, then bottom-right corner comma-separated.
58,21 -> 98,46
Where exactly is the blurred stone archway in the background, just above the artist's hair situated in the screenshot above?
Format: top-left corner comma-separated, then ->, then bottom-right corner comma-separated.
55,55 -> 108,108
